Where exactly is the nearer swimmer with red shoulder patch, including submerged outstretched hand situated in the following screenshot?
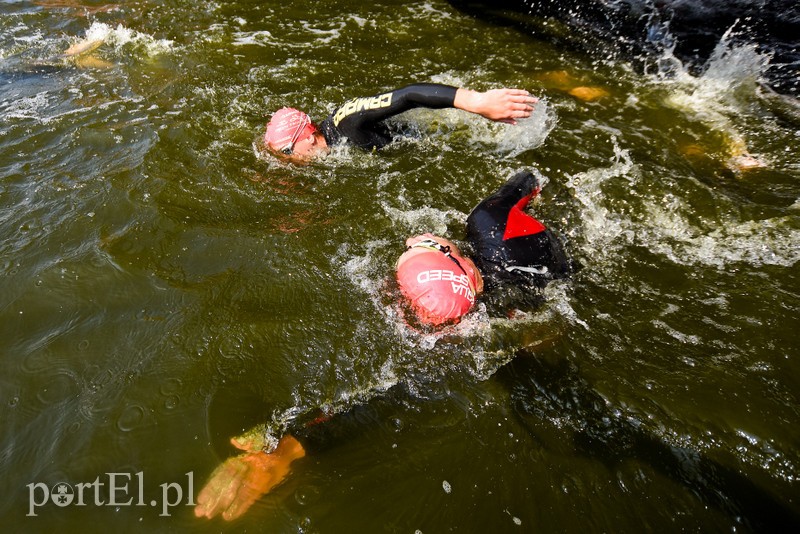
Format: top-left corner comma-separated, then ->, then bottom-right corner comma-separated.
195,171 -> 570,520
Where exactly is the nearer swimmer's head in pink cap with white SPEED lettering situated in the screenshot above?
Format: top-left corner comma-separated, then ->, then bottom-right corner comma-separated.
397,234 -> 483,326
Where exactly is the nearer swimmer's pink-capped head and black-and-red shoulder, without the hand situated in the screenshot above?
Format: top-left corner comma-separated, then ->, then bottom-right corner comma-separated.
396,171 -> 572,326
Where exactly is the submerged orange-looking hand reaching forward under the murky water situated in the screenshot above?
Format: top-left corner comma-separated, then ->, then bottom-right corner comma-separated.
194,435 -> 306,521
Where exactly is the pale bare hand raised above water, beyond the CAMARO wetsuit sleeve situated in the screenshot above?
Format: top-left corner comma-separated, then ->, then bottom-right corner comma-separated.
453,88 -> 539,124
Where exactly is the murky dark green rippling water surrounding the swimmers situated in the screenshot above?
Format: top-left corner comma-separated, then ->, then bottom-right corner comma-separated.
0,0 -> 800,533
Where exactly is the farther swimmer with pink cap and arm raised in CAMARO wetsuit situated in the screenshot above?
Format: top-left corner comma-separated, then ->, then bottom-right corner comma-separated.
264,83 -> 538,162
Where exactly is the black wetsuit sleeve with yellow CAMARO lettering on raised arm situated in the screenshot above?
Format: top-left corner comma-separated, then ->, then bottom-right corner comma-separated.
320,83 -> 458,150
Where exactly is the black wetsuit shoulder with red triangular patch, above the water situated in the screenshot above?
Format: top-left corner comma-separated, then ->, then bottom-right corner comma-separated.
467,171 -> 572,288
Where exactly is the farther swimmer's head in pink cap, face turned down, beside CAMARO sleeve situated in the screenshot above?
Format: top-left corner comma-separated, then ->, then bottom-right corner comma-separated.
264,108 -> 328,161
